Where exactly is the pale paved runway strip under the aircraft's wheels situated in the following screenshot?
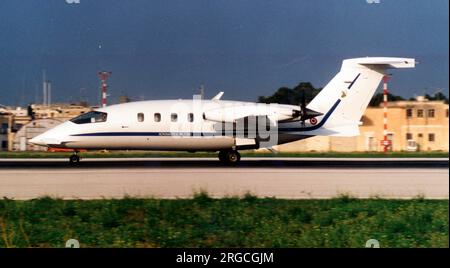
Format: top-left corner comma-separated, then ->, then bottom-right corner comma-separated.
0,158 -> 449,200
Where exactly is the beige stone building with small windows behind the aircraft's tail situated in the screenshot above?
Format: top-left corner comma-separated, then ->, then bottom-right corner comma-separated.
278,97 -> 449,152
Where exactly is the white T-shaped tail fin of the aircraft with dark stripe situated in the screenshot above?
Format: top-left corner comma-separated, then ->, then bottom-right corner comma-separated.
307,57 -> 415,137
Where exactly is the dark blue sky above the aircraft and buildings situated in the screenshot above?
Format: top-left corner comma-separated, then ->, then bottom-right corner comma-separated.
0,0 -> 449,105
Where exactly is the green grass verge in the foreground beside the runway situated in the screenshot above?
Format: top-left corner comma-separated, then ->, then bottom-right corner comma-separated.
0,193 -> 449,248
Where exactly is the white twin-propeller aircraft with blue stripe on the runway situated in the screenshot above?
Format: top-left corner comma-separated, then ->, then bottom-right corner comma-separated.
30,57 -> 415,164
